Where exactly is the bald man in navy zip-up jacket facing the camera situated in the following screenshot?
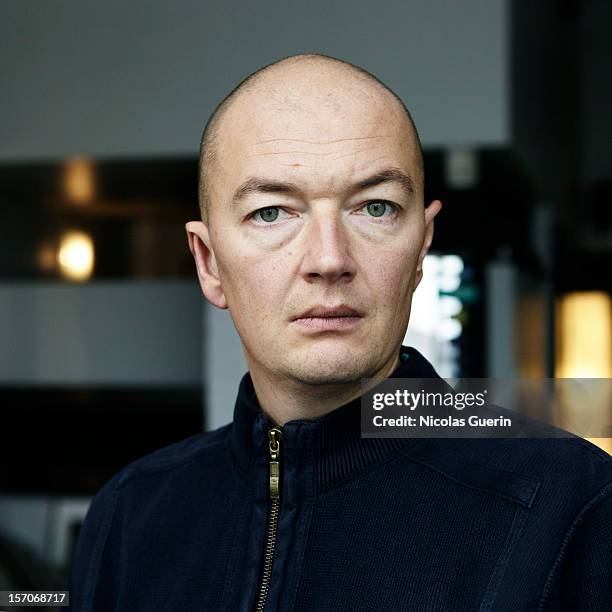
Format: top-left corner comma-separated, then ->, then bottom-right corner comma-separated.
71,54 -> 612,612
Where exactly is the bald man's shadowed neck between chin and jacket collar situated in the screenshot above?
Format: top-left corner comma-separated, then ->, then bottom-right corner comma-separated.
247,347 -> 399,426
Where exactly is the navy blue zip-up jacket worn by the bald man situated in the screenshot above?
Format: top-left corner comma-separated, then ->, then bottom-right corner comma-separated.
69,347 -> 612,612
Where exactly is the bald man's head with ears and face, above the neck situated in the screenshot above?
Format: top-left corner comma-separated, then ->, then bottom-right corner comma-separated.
187,54 -> 441,385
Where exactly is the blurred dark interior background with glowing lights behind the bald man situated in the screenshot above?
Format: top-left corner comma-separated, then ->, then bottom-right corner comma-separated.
0,0 -> 612,590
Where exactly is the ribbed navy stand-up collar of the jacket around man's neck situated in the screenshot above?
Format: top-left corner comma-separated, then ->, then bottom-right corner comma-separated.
232,346 -> 439,491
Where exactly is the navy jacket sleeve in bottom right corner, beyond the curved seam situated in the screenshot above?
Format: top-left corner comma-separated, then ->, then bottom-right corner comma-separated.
540,483 -> 612,612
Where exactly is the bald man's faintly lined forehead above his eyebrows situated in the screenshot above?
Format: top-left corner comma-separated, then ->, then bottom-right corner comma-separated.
215,83 -> 416,194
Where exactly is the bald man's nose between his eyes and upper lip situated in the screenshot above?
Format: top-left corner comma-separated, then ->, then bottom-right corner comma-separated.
302,210 -> 356,283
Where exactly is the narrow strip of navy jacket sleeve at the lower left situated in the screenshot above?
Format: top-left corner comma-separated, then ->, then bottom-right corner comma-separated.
68,474 -> 120,612
